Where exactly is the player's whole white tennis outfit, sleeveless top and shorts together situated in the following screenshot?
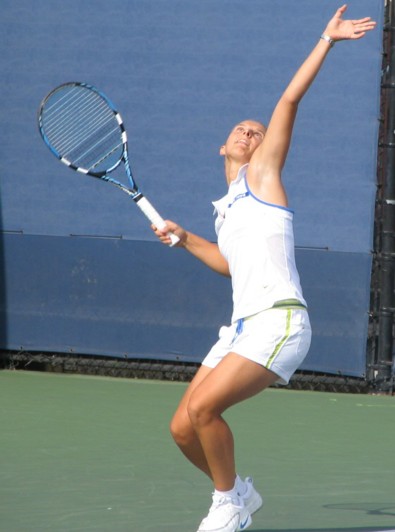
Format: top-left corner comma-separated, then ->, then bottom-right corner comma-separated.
203,165 -> 311,384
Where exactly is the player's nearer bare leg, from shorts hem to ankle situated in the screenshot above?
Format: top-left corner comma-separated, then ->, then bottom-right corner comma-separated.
187,353 -> 278,491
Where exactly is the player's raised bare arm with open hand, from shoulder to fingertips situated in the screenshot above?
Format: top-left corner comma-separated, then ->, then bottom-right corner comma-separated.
248,5 -> 376,206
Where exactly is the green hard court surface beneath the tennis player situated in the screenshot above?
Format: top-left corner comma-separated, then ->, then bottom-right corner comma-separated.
0,371 -> 395,532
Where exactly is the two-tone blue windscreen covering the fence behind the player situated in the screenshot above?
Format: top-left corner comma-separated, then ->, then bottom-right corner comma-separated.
0,0 -> 383,376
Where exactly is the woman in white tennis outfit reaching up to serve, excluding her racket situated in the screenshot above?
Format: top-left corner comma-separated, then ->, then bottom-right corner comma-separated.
153,5 -> 375,532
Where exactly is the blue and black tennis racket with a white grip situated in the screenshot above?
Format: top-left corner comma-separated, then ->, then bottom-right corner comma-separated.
38,82 -> 179,246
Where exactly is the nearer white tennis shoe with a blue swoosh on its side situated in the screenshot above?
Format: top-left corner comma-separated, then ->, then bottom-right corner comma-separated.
197,495 -> 252,532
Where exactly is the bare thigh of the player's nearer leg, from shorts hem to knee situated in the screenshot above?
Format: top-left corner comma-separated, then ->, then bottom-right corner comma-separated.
186,353 -> 279,414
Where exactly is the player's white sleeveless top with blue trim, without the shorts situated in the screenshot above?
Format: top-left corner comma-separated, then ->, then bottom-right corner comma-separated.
213,165 -> 306,322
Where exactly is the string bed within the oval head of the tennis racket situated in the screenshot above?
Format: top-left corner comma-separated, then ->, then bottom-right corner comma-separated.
42,86 -> 125,172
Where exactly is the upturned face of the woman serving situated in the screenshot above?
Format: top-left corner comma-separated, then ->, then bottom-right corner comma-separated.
220,120 -> 266,163
